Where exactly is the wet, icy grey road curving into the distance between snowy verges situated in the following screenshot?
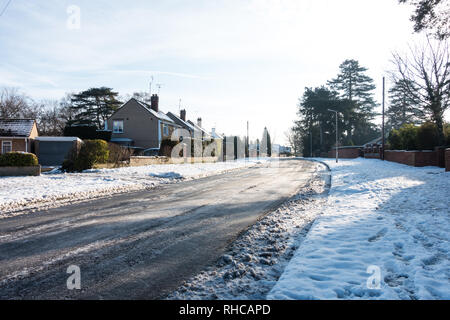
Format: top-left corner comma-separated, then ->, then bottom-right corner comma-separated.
0,160 -> 323,299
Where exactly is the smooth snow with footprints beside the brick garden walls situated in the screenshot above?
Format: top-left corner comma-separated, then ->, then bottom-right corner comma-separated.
267,159 -> 450,299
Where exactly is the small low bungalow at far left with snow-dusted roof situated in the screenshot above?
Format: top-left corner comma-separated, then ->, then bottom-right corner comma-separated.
0,119 -> 39,154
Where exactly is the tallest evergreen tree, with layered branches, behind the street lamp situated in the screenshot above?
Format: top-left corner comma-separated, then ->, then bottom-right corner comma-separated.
328,59 -> 376,143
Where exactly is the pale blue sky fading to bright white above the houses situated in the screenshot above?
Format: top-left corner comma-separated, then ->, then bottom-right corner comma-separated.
0,0 -> 424,143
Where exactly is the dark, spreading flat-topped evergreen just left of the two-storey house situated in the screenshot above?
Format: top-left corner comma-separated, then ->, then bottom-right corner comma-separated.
67,87 -> 122,129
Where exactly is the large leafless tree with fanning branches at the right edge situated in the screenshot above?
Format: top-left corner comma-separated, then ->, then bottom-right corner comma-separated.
391,37 -> 450,145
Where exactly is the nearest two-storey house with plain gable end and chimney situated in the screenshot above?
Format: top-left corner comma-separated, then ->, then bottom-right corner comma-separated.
105,94 -> 181,149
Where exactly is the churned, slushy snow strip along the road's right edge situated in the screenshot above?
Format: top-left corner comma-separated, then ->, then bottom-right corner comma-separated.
167,163 -> 329,300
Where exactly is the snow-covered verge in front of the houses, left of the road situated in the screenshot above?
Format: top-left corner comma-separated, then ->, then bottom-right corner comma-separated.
0,158 -> 268,219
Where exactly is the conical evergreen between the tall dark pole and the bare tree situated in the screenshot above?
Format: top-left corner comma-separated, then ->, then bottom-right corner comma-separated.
386,79 -> 425,130
